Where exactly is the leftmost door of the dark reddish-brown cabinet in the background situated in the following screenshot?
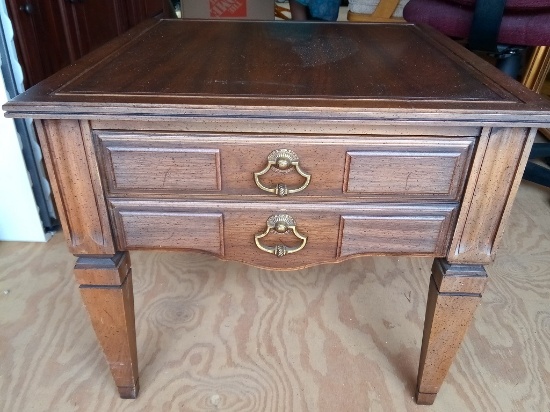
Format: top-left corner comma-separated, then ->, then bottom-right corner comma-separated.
6,0 -> 77,88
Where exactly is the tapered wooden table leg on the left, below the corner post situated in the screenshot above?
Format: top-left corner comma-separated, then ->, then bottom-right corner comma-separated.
75,252 -> 139,399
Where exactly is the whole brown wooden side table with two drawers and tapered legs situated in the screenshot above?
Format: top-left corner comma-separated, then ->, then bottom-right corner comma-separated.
4,20 -> 550,404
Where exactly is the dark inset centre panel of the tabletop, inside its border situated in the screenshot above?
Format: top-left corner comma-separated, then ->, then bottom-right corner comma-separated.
55,20 -> 517,102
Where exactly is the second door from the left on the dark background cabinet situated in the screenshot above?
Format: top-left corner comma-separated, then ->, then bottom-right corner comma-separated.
58,0 -> 129,57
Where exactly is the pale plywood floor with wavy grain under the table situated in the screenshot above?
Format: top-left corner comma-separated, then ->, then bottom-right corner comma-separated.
0,183 -> 550,412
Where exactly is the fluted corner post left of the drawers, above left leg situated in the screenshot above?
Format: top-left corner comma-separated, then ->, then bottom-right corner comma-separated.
36,120 -> 115,255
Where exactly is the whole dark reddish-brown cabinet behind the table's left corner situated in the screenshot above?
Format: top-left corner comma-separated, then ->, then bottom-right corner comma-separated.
6,0 -> 167,88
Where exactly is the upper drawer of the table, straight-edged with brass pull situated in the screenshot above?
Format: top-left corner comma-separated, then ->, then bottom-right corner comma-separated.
95,131 -> 475,201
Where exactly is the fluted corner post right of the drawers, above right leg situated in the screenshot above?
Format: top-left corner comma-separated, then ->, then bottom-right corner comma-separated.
447,128 -> 536,263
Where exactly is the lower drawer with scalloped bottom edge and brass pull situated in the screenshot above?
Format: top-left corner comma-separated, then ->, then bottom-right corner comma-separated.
111,199 -> 457,269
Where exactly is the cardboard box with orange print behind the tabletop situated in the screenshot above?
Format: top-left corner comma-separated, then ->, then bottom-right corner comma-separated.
181,0 -> 275,20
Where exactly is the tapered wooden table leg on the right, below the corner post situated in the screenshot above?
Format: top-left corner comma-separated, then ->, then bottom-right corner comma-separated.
416,259 -> 487,405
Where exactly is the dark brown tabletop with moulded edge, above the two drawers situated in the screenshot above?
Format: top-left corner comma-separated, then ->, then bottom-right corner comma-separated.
4,20 -> 550,125
